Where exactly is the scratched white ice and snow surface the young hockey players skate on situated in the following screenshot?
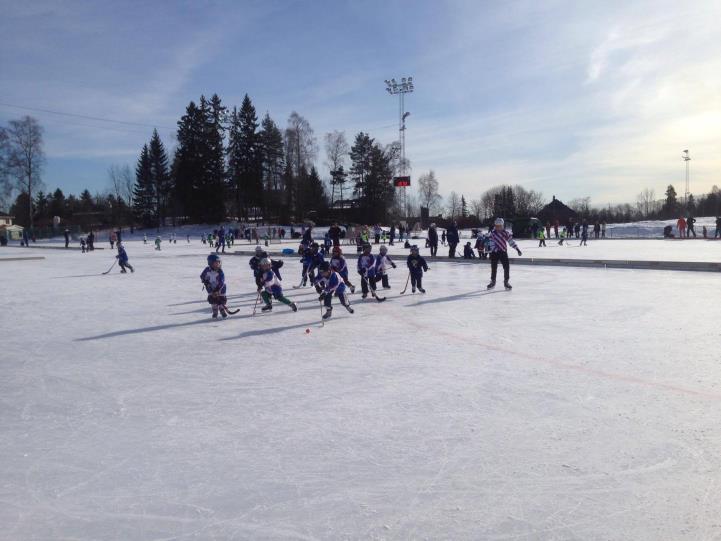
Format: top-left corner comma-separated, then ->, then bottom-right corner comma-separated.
0,239 -> 721,540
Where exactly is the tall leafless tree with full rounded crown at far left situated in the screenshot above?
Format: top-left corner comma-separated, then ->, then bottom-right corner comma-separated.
7,116 -> 45,229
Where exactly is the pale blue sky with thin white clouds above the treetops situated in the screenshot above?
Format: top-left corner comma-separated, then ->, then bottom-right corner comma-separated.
0,0 -> 721,206
